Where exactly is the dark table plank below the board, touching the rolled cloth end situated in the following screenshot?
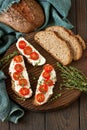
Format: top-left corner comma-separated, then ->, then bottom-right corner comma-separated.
10,111 -> 45,130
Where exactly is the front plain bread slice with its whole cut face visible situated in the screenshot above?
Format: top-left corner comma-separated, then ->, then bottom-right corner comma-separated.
34,31 -> 72,65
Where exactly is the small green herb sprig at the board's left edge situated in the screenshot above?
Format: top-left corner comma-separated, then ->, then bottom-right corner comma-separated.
0,51 -> 18,68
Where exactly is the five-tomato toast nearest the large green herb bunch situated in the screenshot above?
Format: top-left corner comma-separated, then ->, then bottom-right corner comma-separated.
34,64 -> 57,106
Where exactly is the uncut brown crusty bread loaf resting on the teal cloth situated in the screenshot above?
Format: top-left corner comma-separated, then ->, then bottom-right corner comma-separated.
0,0 -> 44,33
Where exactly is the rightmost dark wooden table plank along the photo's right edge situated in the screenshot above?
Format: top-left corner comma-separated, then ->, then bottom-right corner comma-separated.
76,0 -> 87,130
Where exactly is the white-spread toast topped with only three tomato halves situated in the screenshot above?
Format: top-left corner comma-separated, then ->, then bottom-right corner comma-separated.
16,37 -> 46,66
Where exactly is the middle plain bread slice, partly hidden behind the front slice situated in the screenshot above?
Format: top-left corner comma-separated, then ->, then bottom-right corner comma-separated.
46,26 -> 82,60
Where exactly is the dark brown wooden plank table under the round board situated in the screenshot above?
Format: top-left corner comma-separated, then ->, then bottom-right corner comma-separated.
0,0 -> 87,130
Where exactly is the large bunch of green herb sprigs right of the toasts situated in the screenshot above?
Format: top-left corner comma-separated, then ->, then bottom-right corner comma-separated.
57,62 -> 87,92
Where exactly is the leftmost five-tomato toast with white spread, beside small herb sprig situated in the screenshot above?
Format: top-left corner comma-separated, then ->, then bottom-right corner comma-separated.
9,55 -> 32,98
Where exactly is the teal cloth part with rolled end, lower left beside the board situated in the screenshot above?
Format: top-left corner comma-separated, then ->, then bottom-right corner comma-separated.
0,71 -> 24,123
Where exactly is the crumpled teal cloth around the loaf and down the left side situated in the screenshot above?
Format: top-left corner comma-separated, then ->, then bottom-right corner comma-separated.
0,0 -> 73,123
